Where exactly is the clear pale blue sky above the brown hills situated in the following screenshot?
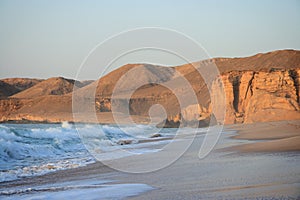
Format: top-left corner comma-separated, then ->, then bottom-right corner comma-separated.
0,0 -> 300,79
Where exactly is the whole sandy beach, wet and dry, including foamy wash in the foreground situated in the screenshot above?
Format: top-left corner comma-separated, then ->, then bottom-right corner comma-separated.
0,121 -> 300,199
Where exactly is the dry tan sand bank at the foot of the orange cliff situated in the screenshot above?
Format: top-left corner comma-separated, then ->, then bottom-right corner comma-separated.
229,121 -> 300,153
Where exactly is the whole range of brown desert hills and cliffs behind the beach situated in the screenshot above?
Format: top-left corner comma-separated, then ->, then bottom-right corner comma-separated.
0,50 -> 300,127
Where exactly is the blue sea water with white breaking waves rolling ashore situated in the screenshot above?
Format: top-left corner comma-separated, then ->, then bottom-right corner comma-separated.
0,122 -> 178,182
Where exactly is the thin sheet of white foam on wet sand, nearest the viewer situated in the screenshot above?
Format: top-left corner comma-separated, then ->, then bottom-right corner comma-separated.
0,180 -> 154,200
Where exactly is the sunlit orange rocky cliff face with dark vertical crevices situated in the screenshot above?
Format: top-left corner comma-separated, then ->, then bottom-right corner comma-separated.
214,69 -> 300,124
